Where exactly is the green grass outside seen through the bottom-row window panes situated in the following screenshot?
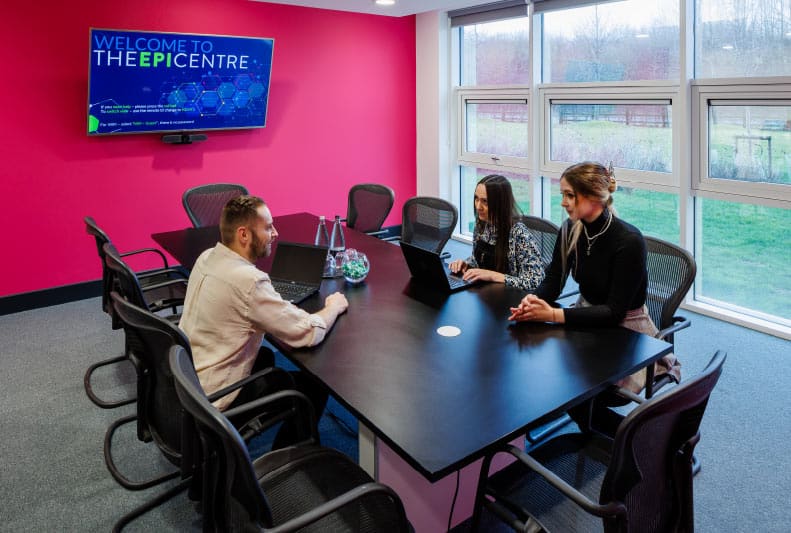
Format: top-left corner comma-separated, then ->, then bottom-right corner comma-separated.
460,167 -> 791,319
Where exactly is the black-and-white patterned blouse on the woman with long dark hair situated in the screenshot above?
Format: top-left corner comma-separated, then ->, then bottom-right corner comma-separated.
465,222 -> 544,291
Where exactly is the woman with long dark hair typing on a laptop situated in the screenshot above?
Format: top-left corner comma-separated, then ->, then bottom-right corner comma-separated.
449,174 -> 544,290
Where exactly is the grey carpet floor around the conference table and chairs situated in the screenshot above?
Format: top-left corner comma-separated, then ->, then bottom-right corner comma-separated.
0,299 -> 791,532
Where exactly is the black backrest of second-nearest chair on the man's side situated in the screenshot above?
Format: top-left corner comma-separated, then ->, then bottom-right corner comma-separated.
110,291 -> 192,465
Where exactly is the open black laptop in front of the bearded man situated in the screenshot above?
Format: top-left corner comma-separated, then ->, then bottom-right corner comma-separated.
269,242 -> 327,304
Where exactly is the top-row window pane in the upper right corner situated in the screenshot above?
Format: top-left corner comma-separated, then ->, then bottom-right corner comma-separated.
695,0 -> 791,78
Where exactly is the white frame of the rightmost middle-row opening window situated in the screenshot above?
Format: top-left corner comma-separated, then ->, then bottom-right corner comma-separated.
690,77 -> 791,204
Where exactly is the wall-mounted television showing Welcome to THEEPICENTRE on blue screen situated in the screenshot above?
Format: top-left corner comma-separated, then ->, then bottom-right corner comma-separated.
88,28 -> 274,136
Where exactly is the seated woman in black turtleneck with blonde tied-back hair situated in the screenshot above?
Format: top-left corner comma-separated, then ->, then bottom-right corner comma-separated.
509,162 -> 680,434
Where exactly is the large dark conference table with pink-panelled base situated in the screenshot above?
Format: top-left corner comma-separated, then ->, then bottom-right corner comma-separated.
152,213 -> 672,531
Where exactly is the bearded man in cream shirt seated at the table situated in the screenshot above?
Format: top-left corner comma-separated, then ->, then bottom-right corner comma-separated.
184,195 -> 349,445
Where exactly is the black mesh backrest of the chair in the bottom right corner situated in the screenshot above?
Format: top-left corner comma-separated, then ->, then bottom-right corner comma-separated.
599,351 -> 726,531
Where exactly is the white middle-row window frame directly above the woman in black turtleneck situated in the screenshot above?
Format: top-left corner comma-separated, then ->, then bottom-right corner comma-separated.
537,82 -> 681,193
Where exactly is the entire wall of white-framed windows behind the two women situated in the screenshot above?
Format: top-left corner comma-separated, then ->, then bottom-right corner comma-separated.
446,0 -> 791,336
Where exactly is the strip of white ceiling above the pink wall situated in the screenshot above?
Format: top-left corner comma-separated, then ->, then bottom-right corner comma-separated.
253,0 -> 493,17
